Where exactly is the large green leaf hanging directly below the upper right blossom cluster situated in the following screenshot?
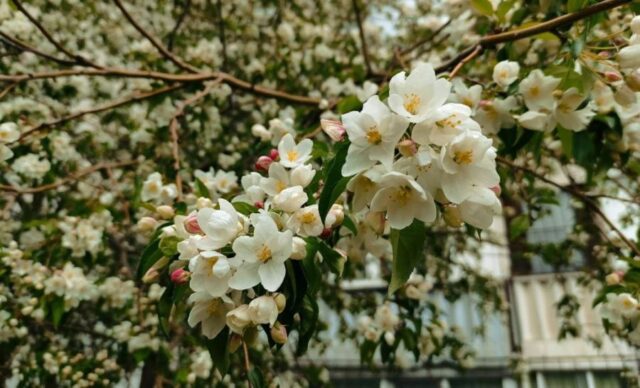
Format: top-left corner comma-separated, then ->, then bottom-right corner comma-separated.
389,219 -> 427,295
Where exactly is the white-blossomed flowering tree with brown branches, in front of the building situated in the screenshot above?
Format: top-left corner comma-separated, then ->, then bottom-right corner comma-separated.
0,0 -> 640,387
